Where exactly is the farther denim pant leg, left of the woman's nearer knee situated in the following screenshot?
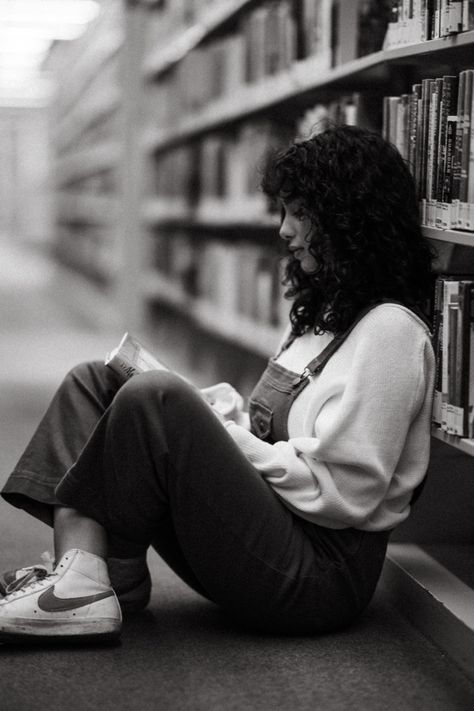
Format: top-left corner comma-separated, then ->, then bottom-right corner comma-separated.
1,361 -> 122,526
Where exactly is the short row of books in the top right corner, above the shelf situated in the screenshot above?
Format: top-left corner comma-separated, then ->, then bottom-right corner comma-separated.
383,0 -> 474,49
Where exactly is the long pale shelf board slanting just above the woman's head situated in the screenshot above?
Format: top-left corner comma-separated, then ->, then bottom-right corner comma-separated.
144,31 -> 474,152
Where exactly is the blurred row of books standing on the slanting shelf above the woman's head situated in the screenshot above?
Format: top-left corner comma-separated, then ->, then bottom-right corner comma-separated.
149,0 -> 390,120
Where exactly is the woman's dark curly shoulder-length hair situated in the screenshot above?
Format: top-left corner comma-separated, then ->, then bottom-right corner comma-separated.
261,126 -> 434,336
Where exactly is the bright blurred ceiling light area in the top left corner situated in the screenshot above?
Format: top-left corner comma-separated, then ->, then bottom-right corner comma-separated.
0,0 -> 100,101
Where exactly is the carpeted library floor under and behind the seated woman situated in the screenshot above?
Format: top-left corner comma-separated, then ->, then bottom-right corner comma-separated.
0,240 -> 474,711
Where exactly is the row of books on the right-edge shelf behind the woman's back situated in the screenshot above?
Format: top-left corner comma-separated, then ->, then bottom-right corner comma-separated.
433,276 -> 474,439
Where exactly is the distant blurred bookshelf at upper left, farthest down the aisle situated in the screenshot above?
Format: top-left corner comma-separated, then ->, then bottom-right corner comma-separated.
52,0 -> 124,294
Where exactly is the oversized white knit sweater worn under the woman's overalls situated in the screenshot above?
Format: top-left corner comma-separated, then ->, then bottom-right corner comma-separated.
226,304 -> 435,531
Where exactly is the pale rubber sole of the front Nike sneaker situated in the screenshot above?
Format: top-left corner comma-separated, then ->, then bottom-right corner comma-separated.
0,618 -> 122,643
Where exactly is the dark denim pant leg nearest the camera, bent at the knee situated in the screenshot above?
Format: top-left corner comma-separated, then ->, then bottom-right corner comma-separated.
56,372 -> 386,633
